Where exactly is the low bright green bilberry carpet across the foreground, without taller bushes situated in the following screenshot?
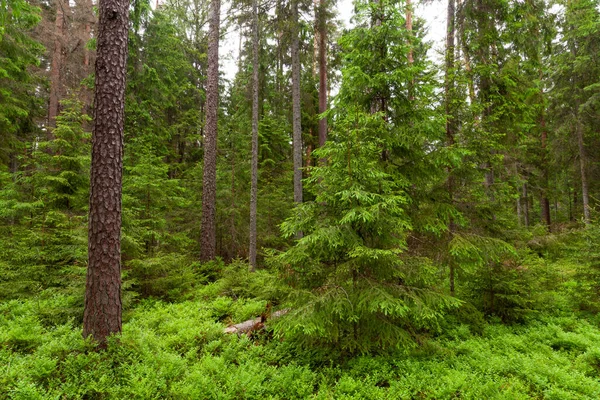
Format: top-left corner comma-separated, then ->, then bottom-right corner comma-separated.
0,282 -> 600,400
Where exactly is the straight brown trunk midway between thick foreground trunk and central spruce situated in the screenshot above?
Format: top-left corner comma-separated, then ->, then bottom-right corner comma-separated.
200,0 -> 221,261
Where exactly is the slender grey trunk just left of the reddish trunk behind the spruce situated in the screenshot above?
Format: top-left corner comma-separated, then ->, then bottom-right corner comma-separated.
291,0 -> 302,228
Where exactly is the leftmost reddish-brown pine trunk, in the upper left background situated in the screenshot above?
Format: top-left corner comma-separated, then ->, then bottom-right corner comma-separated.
48,0 -> 69,128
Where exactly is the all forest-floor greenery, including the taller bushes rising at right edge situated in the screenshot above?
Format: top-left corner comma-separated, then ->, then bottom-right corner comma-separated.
0,230 -> 600,400
